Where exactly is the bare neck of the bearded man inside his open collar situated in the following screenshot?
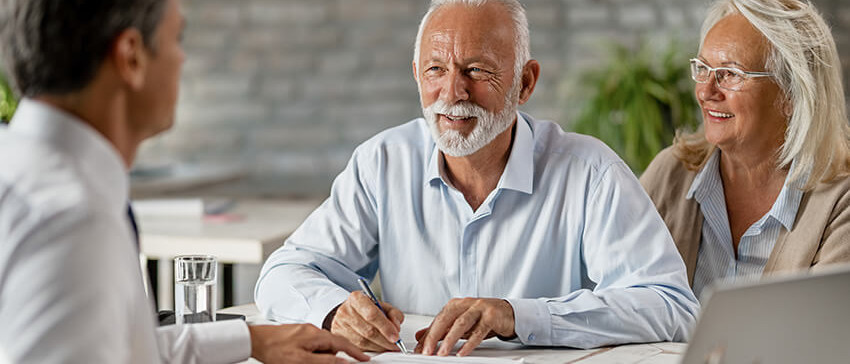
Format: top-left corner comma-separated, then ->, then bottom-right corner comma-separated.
443,120 -> 516,210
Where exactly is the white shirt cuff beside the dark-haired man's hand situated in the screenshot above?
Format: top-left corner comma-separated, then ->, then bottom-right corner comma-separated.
196,320 -> 251,363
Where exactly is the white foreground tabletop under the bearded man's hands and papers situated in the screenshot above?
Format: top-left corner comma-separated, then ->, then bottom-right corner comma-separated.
219,304 -> 687,364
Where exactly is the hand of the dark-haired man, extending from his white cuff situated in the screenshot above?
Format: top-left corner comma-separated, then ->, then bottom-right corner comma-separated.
243,324 -> 369,363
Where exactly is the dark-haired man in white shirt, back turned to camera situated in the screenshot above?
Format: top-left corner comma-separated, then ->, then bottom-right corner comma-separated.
0,0 -> 368,363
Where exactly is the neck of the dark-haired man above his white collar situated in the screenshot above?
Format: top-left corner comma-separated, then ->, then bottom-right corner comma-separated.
35,87 -> 142,170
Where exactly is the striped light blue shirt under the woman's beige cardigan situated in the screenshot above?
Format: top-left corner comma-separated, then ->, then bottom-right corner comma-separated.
686,149 -> 805,300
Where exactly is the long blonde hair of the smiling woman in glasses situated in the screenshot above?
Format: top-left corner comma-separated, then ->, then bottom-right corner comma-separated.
673,0 -> 850,190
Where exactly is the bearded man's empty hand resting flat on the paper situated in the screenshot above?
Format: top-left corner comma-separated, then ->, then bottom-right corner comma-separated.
414,298 -> 516,356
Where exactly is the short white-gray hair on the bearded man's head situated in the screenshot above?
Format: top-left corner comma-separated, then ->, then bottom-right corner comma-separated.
413,0 -> 531,83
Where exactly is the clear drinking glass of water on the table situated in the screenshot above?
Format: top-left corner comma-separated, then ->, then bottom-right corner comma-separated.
174,255 -> 218,325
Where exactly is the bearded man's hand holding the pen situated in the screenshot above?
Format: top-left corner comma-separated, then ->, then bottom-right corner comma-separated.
331,291 -> 404,352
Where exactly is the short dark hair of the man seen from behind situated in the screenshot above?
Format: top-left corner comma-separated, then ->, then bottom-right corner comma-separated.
0,0 -> 166,97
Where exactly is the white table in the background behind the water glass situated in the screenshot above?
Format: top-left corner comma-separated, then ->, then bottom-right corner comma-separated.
139,200 -> 321,308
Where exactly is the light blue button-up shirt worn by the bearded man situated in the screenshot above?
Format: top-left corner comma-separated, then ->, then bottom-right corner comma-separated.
255,114 -> 699,348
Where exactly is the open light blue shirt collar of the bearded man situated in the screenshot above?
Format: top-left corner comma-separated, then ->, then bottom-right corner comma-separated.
425,112 -> 534,194
